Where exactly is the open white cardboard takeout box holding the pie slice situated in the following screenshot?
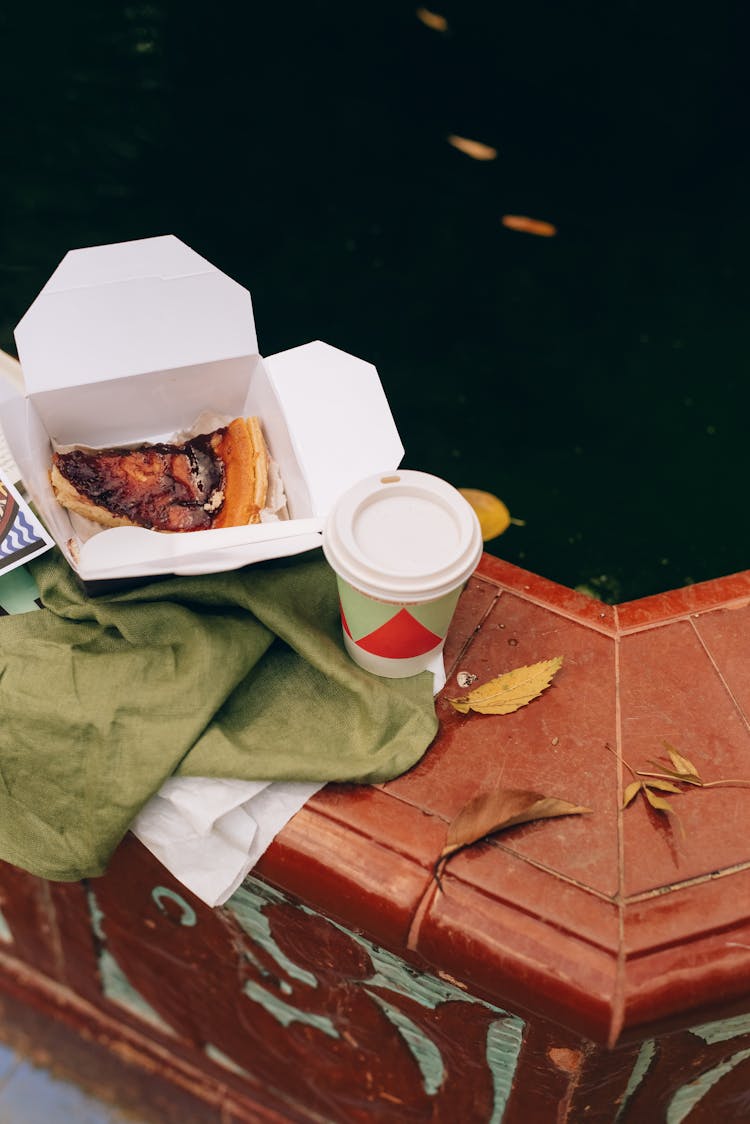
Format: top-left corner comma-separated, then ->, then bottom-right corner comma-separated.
0,235 -> 404,583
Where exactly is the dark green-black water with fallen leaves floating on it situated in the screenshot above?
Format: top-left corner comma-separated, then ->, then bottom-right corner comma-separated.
0,0 -> 750,600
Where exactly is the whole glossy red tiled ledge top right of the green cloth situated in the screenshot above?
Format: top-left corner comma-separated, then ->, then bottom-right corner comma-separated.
259,555 -> 750,1044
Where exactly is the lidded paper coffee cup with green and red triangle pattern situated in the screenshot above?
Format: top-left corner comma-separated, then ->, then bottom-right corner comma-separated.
323,470 -> 482,679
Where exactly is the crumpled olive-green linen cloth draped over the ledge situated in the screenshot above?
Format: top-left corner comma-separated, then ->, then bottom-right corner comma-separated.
0,550 -> 437,881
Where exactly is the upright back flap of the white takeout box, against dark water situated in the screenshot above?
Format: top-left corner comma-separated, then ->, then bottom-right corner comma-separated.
16,235 -> 257,393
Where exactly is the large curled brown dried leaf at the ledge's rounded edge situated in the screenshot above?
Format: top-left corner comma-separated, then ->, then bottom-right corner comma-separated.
440,788 -> 591,859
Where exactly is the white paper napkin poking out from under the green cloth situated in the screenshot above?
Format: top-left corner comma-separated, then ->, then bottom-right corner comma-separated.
132,652 -> 445,906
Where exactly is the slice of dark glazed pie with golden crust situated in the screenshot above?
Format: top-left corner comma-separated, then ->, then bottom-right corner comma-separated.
49,417 -> 268,531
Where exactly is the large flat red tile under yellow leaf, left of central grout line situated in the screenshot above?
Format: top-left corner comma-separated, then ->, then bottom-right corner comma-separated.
385,593 -> 617,894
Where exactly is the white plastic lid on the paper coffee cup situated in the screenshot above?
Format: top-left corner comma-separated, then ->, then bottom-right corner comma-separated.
323,470 -> 482,601
